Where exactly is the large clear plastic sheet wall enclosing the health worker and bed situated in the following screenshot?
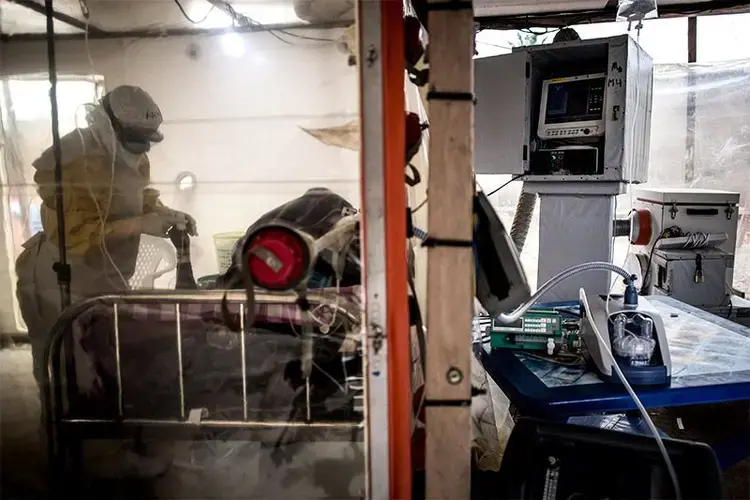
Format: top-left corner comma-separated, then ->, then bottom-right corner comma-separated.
0,10 -> 388,499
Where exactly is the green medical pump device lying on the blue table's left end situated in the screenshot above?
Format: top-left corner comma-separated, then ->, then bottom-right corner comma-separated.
490,309 -> 563,351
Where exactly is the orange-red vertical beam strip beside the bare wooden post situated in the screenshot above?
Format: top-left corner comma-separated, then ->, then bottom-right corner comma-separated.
381,0 -> 412,500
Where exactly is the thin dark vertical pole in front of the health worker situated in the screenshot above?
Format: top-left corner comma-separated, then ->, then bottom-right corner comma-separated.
44,0 -> 71,309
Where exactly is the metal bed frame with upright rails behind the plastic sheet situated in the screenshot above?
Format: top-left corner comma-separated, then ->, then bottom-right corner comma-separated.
43,290 -> 365,484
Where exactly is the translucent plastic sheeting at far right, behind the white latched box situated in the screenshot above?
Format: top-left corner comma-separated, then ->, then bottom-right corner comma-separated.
648,60 -> 750,291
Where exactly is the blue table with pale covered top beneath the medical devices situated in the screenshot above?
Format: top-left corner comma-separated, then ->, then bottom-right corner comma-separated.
474,296 -> 750,418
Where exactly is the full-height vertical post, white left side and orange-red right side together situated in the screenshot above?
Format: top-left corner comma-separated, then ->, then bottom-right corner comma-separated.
357,0 -> 413,500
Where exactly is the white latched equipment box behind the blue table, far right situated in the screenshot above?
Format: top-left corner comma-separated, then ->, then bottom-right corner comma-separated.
633,188 -> 740,292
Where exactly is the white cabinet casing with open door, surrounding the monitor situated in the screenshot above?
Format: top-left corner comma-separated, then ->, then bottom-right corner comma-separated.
474,35 -> 653,183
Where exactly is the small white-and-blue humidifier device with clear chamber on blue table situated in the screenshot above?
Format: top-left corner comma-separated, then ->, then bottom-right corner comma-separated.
581,296 -> 672,386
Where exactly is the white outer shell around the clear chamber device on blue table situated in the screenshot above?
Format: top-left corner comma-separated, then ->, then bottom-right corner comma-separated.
581,296 -> 672,385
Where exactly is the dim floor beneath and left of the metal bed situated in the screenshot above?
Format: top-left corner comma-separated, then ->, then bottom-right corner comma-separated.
0,346 -> 364,500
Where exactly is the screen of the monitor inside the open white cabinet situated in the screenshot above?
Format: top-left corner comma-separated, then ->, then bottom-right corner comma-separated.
544,76 -> 605,125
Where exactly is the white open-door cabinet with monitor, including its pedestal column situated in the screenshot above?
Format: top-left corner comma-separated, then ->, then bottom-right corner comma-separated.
475,35 -> 653,302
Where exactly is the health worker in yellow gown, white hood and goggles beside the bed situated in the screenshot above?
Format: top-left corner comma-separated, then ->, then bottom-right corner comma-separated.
16,85 -> 196,400
